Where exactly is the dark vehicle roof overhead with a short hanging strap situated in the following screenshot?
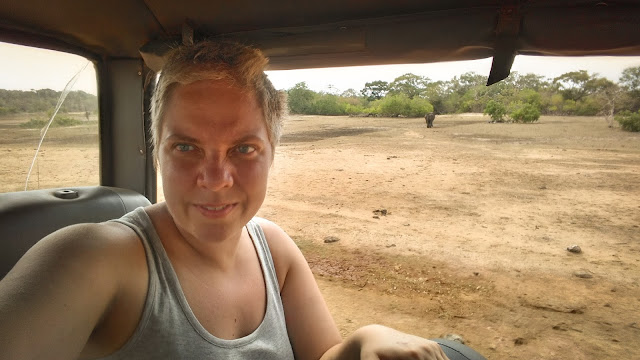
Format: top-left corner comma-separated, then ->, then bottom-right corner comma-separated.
0,0 -> 640,82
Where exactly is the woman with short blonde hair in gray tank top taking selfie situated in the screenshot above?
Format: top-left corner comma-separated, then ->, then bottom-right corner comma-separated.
0,41 -> 446,359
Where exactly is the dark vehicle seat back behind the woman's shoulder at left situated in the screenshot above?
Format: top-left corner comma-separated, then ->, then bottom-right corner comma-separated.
0,186 -> 151,279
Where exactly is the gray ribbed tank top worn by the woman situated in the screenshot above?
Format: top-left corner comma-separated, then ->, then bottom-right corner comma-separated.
104,208 -> 294,360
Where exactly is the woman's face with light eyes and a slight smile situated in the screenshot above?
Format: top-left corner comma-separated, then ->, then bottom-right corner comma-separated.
158,80 -> 273,241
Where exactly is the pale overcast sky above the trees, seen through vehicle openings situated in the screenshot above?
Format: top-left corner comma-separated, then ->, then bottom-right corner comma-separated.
0,43 -> 640,94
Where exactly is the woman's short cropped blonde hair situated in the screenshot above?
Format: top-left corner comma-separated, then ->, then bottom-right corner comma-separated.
151,40 -> 286,162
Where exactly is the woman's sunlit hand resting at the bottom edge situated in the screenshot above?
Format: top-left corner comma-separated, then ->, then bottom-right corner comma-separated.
358,325 -> 449,360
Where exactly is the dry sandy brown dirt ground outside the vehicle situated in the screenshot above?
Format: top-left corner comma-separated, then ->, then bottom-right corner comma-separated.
0,114 -> 640,359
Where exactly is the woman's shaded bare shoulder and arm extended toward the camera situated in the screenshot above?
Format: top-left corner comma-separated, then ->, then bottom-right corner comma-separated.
0,222 -> 146,359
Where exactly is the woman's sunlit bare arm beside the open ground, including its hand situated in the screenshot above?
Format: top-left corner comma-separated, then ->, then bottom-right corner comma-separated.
261,221 -> 447,360
